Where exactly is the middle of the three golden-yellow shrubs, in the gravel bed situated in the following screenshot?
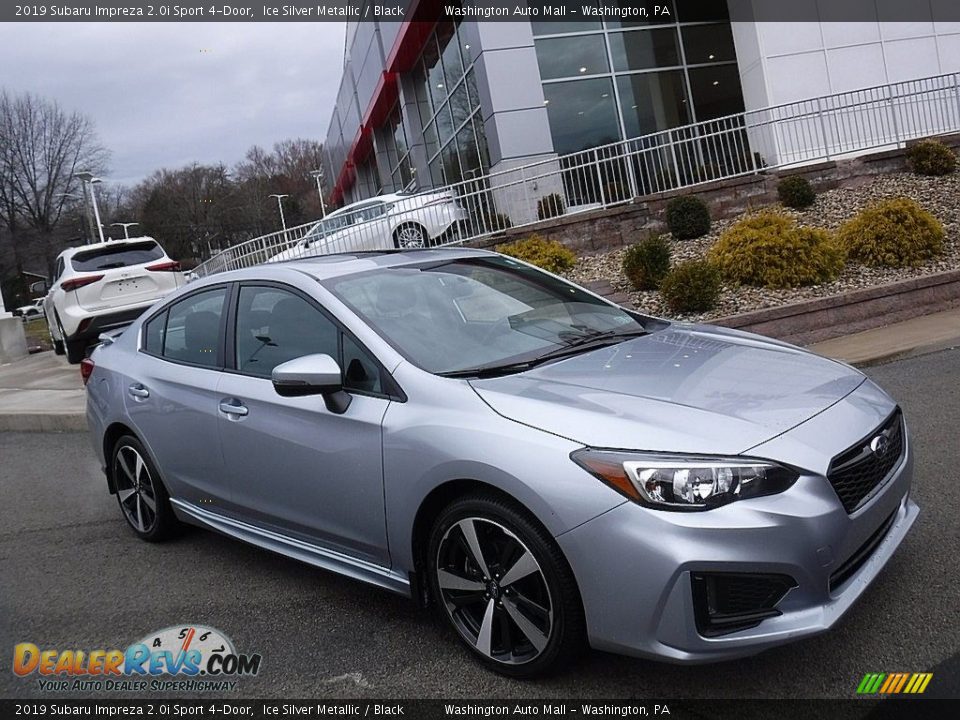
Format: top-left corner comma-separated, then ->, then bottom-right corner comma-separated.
707,210 -> 844,288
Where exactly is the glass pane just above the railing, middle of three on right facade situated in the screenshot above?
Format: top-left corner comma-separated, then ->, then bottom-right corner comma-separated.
617,70 -> 690,137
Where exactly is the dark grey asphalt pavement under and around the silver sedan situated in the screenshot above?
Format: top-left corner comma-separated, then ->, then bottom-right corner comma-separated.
0,349 -> 960,698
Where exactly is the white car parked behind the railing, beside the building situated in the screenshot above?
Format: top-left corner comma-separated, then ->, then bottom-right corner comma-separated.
268,190 -> 467,262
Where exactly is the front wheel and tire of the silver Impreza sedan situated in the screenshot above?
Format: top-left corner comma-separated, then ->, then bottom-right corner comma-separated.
427,494 -> 586,678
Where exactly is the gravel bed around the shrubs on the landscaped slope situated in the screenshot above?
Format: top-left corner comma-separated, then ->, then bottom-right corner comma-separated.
564,173 -> 960,321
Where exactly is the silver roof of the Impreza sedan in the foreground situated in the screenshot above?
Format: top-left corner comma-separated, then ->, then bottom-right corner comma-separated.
204,248 -> 497,282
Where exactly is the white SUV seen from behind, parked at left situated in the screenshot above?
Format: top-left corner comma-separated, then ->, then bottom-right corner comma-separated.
43,237 -> 184,363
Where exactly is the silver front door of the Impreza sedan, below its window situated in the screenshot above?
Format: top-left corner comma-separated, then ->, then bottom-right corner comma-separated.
218,375 -> 389,565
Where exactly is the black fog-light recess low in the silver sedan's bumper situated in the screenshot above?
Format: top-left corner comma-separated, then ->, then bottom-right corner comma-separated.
690,573 -> 797,637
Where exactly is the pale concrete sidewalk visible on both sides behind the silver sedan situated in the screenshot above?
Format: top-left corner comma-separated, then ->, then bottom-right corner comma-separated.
0,308 -> 960,432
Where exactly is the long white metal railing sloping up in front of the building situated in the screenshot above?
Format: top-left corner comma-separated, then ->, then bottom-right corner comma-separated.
194,73 -> 960,275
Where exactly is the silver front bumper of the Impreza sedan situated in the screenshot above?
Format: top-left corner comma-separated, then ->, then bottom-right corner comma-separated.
557,402 -> 919,663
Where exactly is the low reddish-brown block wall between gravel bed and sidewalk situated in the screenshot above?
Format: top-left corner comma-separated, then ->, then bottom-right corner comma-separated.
710,270 -> 960,345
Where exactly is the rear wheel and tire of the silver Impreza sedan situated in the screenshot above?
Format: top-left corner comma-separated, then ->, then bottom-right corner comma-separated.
110,435 -> 180,542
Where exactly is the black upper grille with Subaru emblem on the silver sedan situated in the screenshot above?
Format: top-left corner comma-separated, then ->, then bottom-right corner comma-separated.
827,408 -> 904,513
